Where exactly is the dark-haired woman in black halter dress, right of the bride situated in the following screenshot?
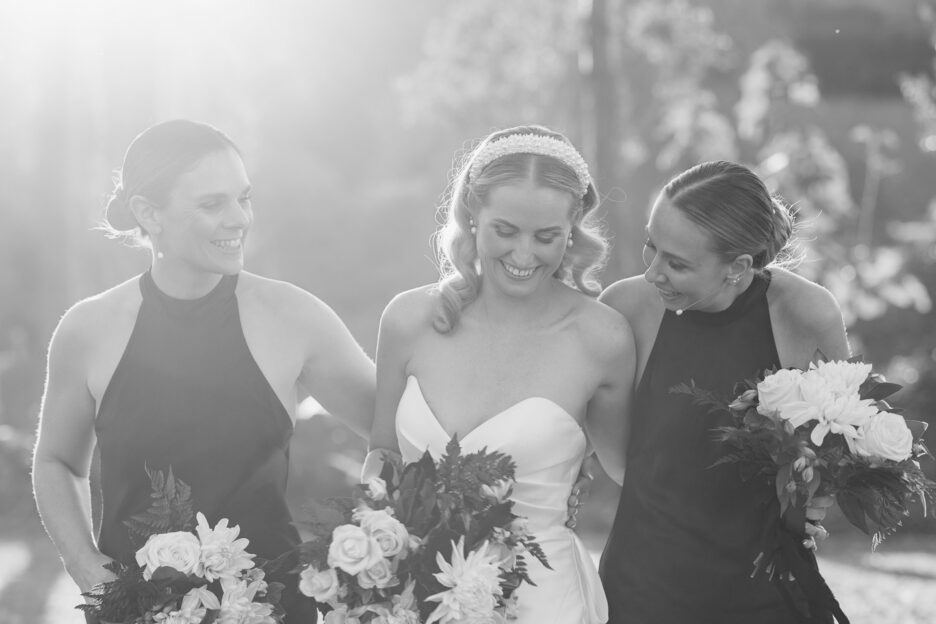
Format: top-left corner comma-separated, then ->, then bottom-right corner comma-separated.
601,162 -> 849,624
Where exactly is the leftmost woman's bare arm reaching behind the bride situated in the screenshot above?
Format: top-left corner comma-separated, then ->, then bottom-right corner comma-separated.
299,298 -> 376,439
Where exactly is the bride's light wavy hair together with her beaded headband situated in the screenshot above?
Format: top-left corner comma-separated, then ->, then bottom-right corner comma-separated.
435,126 -> 608,333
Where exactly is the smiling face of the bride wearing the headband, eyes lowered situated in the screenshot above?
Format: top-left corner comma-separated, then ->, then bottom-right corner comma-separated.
475,180 -> 574,297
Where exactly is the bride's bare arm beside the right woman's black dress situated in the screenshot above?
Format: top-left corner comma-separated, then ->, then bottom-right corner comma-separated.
586,317 -> 636,485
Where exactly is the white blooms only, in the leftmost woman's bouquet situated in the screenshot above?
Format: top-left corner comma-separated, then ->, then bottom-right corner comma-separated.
136,513 -> 275,624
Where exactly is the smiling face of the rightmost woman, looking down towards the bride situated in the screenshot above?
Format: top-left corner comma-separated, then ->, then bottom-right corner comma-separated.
644,195 -> 740,312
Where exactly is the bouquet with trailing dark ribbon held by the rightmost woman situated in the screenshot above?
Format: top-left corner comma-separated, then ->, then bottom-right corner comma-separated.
672,354 -> 936,622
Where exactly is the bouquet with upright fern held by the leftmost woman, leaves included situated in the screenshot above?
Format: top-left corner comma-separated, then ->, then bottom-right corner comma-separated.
77,468 -> 283,624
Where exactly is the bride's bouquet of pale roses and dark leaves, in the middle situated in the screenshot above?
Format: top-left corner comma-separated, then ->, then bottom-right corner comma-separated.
296,439 -> 549,624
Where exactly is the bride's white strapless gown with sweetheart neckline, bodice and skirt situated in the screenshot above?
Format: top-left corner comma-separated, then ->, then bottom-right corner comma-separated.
396,376 -> 608,624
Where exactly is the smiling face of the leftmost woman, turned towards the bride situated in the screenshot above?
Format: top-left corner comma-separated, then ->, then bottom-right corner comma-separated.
157,150 -> 253,276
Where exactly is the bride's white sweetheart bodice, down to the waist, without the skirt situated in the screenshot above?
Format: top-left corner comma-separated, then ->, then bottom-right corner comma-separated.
396,375 -> 588,533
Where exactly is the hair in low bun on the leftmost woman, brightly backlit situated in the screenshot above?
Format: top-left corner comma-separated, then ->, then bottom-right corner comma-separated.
101,119 -> 240,246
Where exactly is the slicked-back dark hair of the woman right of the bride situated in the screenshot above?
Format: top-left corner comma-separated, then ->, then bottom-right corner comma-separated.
663,160 -> 794,269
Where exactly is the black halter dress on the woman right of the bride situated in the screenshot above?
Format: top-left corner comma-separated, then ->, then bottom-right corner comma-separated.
601,274 -> 816,624
